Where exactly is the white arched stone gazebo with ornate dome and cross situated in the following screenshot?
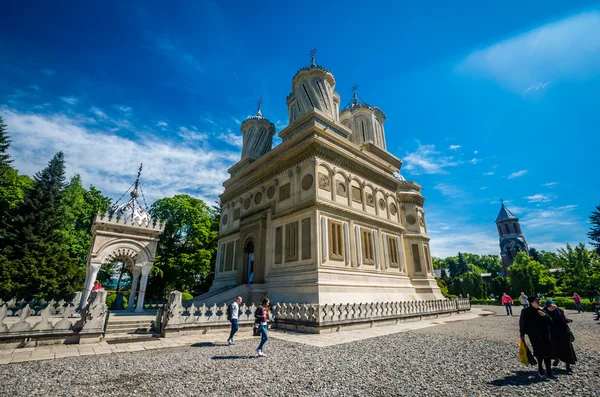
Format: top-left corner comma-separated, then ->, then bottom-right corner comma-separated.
81,165 -> 164,313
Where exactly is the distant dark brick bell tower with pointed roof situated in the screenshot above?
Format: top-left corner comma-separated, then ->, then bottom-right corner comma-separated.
496,203 -> 529,275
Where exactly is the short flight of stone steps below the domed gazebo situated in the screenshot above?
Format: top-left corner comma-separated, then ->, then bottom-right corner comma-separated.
104,311 -> 159,343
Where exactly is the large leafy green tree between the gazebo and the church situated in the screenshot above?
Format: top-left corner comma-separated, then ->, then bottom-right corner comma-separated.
150,194 -> 219,298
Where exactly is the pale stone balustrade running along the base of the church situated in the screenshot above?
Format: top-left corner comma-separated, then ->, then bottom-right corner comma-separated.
161,291 -> 470,336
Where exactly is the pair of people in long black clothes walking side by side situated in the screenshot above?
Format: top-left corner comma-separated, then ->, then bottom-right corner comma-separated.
519,294 -> 577,379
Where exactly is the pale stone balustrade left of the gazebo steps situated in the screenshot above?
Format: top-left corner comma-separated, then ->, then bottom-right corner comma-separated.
0,290 -> 108,349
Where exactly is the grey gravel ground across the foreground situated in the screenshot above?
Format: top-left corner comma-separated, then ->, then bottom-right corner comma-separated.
0,308 -> 600,397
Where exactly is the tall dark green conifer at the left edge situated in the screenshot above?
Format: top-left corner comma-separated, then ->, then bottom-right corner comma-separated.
0,152 -> 85,299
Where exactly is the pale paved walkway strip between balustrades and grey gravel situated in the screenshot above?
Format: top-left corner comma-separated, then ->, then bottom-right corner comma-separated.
0,308 -> 491,365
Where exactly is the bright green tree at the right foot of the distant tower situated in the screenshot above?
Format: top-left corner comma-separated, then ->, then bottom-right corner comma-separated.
508,252 -> 556,295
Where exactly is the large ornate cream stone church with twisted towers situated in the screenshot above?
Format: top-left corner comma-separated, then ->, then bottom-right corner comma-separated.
209,57 -> 443,304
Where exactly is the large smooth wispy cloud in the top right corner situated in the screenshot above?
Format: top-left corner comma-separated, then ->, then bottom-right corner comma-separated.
457,11 -> 600,92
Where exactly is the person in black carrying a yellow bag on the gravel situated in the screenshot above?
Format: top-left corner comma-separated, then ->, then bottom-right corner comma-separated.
519,296 -> 556,379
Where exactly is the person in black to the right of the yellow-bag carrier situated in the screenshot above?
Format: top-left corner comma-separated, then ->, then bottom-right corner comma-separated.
544,299 -> 577,374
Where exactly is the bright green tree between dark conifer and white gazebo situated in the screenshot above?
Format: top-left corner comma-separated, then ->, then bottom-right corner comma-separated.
62,174 -> 110,268
